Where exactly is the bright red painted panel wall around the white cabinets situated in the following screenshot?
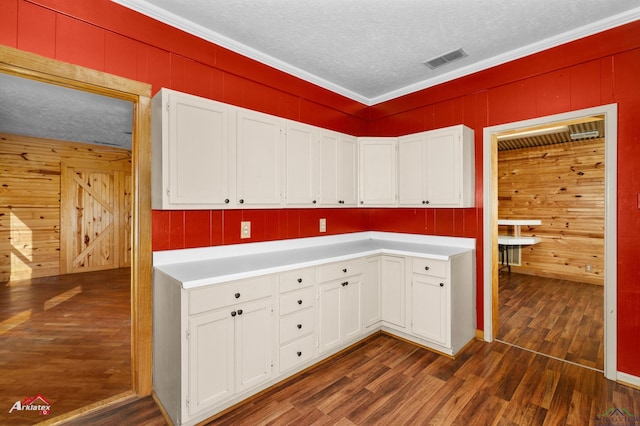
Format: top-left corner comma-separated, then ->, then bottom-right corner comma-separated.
0,0 -> 640,376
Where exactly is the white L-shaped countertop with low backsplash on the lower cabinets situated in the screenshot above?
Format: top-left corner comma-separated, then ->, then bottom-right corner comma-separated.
154,232 -> 475,288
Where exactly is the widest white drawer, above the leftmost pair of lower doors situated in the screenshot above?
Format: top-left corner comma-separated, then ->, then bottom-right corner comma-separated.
189,275 -> 273,315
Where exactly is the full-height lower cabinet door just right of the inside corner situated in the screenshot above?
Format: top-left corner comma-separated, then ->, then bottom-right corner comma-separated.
380,255 -> 408,327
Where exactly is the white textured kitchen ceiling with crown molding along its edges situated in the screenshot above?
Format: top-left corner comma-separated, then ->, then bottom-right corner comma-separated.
114,0 -> 640,105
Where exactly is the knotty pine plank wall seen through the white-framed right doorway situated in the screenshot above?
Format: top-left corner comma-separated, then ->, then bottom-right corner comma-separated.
498,139 -> 605,285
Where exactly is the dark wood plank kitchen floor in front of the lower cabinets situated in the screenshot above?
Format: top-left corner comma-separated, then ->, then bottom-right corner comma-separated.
71,334 -> 640,426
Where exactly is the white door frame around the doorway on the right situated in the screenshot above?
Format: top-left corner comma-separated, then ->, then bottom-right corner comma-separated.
483,104 -> 618,380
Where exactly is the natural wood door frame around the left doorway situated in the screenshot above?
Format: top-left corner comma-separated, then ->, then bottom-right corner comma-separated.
0,46 -> 152,418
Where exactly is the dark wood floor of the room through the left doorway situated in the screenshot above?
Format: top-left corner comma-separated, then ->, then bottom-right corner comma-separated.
0,268 -> 131,425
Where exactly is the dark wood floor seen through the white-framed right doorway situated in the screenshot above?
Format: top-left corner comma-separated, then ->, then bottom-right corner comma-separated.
497,272 -> 604,371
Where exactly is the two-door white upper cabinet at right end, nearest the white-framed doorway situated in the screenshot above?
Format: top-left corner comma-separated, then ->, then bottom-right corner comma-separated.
398,125 -> 475,207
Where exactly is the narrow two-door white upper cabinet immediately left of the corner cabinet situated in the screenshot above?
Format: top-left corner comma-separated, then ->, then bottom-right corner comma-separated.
319,130 -> 358,207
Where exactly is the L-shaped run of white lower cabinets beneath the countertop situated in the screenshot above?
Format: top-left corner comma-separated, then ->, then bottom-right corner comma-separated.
153,238 -> 475,425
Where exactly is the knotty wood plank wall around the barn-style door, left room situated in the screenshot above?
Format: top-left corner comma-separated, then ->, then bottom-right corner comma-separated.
0,134 -> 131,282
